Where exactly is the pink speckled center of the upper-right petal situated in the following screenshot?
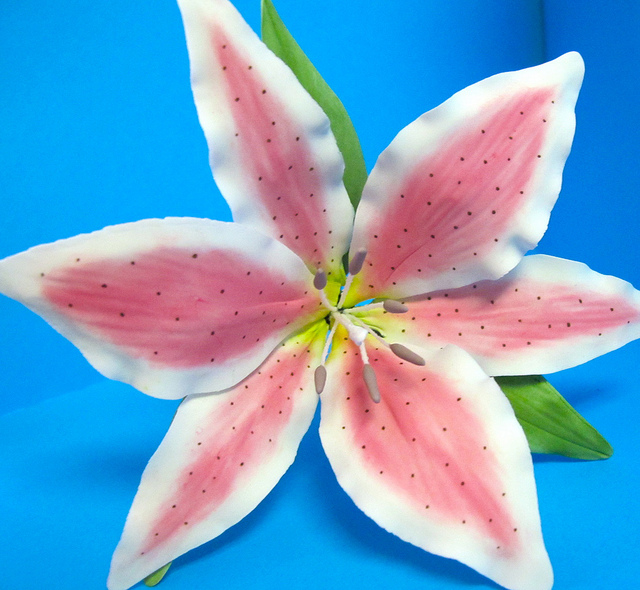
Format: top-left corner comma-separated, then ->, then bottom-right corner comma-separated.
367,90 -> 553,293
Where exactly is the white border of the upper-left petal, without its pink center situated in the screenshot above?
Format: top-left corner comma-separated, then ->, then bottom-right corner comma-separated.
178,0 -> 354,272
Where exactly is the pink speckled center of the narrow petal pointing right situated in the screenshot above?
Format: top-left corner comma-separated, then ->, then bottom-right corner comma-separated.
402,278 -> 640,357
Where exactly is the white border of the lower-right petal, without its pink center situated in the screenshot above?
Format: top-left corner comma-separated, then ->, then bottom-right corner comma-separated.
320,346 -> 553,590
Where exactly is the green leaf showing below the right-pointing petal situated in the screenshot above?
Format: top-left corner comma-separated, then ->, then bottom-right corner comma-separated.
496,375 -> 613,460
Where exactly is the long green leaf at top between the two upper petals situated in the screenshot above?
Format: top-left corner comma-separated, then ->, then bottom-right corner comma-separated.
262,0 -> 367,209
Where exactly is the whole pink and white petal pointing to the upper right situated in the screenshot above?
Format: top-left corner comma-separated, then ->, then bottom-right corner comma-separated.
351,53 -> 584,301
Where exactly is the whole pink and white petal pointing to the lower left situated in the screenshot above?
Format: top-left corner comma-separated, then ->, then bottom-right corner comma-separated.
108,326 -> 326,590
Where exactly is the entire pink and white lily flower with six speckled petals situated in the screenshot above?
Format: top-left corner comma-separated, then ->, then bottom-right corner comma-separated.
0,0 -> 640,590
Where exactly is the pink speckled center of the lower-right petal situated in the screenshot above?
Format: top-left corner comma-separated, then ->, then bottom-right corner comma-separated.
345,350 -> 519,552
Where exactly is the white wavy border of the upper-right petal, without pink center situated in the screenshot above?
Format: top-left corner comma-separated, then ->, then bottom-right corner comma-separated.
350,52 -> 584,297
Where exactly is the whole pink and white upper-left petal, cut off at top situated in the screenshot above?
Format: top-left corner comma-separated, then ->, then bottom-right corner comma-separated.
179,0 -> 353,272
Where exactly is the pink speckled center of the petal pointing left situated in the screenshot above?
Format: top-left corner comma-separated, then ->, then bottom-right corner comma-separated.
42,248 -> 318,368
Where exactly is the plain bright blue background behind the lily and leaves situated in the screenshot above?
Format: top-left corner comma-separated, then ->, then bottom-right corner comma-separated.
0,0 -> 640,590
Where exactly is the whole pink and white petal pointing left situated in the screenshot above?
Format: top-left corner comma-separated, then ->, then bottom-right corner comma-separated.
0,218 -> 322,398
